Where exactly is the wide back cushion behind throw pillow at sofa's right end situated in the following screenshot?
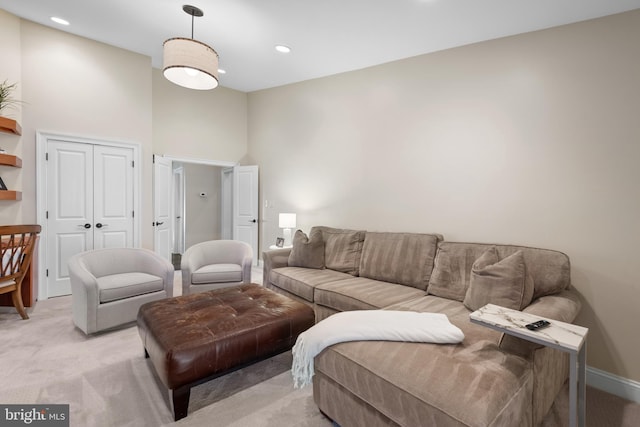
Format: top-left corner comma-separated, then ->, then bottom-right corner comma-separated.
427,242 -> 571,301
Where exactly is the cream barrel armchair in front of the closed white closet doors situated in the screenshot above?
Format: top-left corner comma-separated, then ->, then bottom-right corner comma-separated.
68,248 -> 175,334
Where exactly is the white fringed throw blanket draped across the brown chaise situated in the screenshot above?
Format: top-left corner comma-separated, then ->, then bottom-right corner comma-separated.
291,310 -> 464,388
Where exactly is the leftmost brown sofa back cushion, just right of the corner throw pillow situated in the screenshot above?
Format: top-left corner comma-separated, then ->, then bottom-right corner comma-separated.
309,226 -> 366,276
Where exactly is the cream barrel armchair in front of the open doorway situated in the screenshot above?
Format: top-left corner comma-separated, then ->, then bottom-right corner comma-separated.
181,240 -> 253,295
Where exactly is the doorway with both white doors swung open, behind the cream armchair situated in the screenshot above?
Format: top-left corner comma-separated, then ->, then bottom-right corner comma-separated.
154,155 -> 259,268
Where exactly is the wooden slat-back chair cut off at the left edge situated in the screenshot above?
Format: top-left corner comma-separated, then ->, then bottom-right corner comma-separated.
0,225 -> 41,319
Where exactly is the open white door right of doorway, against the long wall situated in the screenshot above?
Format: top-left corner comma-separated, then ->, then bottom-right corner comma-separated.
233,166 -> 259,265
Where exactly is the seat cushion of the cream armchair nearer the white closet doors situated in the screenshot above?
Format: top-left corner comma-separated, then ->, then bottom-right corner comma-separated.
96,272 -> 164,304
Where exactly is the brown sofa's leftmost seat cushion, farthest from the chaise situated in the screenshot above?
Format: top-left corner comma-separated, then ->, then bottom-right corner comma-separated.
269,267 -> 353,302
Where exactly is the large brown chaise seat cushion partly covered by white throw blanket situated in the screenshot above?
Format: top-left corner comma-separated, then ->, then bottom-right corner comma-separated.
315,297 -> 533,426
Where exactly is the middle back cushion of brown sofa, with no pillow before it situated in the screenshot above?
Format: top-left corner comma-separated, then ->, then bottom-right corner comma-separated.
360,232 -> 441,290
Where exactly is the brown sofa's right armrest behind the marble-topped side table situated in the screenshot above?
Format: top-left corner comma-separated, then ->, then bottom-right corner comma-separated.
500,289 -> 582,357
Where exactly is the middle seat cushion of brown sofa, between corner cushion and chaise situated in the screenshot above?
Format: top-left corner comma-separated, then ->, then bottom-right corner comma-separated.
314,277 -> 425,311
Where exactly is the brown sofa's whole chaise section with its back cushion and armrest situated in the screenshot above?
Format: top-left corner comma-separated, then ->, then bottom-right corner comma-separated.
314,242 -> 580,426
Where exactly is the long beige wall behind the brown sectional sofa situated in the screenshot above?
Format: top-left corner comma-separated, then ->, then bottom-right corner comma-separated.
249,11 -> 640,381
